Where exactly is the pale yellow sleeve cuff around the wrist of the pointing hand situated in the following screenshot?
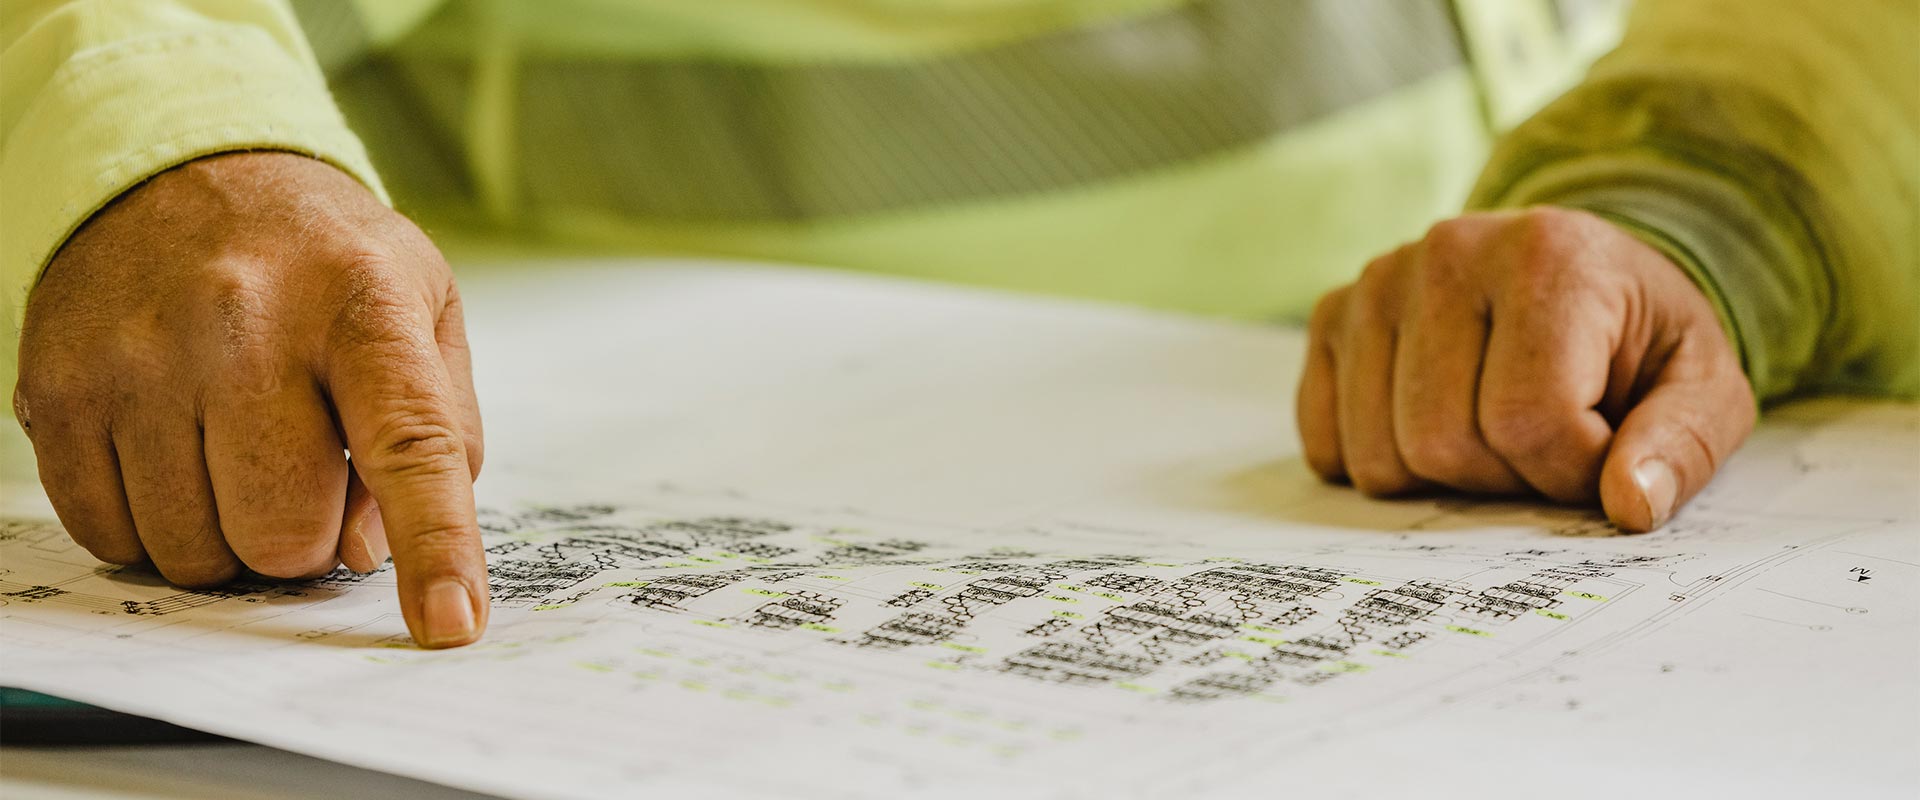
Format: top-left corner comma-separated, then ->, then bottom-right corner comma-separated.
0,27 -> 390,324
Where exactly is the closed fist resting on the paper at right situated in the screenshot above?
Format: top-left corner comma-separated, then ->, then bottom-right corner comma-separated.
1296,207 -> 1755,531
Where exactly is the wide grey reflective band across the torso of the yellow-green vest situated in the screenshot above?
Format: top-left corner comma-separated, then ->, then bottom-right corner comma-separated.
495,0 -> 1461,221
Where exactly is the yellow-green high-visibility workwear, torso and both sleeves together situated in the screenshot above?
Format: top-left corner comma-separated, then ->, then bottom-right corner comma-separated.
0,0 -> 1920,397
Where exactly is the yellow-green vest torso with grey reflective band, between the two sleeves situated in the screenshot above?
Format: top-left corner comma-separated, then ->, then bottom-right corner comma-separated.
296,0 -> 1617,317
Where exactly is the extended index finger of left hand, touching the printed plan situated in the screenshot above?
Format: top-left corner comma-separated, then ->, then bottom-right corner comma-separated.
328,268 -> 488,648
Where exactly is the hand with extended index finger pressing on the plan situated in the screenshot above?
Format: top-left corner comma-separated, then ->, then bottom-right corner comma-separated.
13,153 -> 488,647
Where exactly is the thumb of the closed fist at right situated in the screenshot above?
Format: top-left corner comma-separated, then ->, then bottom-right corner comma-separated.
1599,326 -> 1759,531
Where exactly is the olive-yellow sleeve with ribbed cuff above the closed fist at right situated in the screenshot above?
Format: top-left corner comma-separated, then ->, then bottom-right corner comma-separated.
1473,0 -> 1920,399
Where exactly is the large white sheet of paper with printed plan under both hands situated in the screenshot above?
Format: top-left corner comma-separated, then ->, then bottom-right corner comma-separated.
0,263 -> 1920,798
